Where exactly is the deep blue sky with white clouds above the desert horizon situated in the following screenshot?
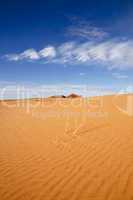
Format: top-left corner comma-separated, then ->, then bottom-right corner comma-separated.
0,0 -> 133,98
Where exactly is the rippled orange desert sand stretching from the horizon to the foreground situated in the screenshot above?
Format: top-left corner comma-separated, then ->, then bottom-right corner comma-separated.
0,95 -> 133,200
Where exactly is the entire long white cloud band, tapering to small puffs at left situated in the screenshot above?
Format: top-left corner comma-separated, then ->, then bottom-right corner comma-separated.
5,40 -> 133,69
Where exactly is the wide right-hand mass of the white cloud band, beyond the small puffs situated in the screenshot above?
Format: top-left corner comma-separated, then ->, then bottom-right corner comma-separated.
56,40 -> 133,69
